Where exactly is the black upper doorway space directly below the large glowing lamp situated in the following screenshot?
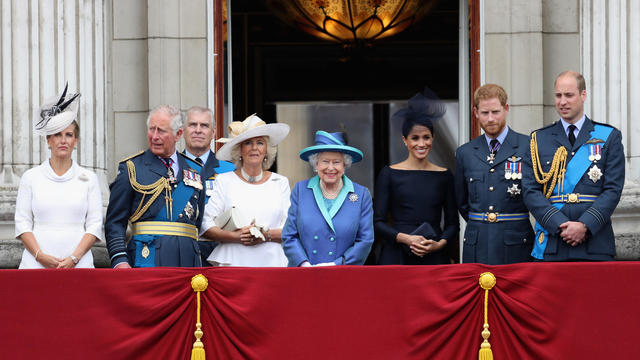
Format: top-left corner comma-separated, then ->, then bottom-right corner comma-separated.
230,0 -> 459,121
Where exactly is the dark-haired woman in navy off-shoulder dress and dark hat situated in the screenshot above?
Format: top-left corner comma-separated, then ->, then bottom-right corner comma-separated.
374,94 -> 459,265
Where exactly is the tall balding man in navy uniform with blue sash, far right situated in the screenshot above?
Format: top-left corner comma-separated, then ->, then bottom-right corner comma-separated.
524,71 -> 624,261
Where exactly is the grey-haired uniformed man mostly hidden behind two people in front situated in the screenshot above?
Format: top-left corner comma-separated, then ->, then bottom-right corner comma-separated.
184,106 -> 235,266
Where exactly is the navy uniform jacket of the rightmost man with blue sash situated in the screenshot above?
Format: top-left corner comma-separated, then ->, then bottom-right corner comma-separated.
523,118 -> 625,261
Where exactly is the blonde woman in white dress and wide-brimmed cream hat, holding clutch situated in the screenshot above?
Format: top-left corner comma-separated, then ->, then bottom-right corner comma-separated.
202,115 -> 291,266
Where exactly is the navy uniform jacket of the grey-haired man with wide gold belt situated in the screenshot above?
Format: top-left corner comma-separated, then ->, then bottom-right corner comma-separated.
104,150 -> 205,266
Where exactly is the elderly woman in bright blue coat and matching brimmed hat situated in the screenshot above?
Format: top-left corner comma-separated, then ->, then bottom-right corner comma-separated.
282,131 -> 373,266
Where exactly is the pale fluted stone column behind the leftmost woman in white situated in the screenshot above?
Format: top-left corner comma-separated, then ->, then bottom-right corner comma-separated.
0,0 -> 107,268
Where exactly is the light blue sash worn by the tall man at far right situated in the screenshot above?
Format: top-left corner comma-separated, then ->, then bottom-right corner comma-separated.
531,124 -> 613,260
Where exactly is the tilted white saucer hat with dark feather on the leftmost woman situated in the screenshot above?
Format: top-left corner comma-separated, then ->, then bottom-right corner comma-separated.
33,84 -> 80,136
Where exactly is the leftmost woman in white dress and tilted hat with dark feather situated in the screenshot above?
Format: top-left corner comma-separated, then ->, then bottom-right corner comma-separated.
15,87 -> 102,269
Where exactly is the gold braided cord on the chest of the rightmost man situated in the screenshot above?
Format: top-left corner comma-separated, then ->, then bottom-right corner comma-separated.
529,131 -> 567,199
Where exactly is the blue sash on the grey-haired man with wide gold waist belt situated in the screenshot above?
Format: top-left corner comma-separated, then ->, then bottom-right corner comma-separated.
132,159 -> 201,267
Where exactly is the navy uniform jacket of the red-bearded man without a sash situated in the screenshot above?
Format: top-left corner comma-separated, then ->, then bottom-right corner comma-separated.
454,128 -> 534,265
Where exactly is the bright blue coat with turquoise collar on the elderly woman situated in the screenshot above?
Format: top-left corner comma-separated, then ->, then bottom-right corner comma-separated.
282,176 -> 373,266
